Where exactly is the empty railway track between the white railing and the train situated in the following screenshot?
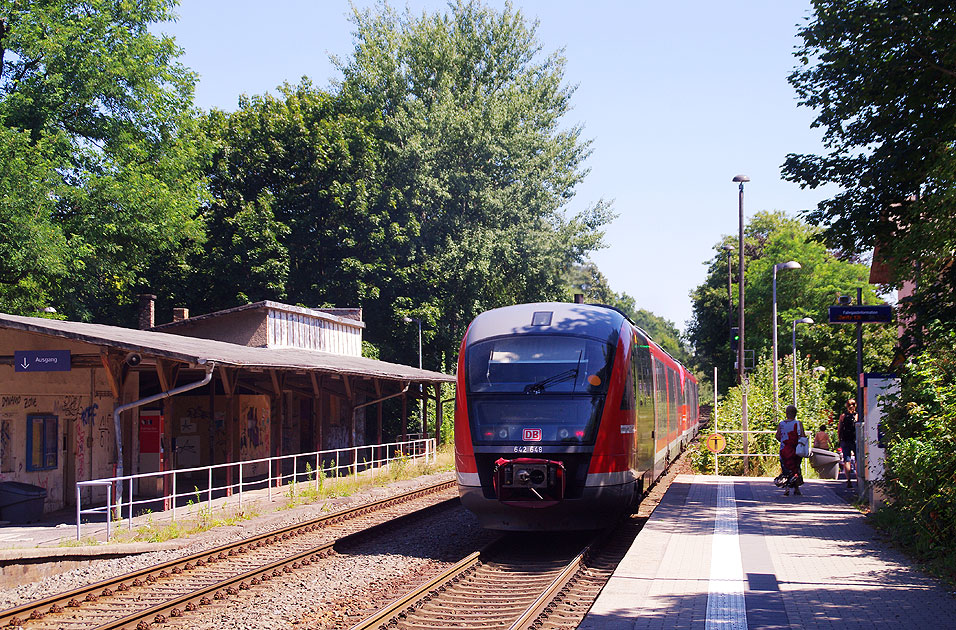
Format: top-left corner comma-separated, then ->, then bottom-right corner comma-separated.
0,482 -> 458,630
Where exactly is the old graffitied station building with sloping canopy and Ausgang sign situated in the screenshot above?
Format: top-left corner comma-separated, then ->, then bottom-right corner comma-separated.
0,302 -> 454,511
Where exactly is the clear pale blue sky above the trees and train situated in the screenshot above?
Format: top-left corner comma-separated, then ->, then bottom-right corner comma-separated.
159,0 -> 833,330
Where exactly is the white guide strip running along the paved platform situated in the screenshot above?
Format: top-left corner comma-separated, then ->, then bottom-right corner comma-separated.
704,480 -> 747,630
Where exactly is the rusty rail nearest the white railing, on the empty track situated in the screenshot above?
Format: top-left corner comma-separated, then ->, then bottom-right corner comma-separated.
0,481 -> 456,628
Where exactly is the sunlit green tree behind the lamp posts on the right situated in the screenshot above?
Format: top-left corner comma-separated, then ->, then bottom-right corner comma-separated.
688,212 -> 895,402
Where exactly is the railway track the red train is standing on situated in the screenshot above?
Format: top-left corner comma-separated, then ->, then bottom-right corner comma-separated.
352,455 -> 686,630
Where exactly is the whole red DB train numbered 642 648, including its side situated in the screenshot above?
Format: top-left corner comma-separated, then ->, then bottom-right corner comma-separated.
455,303 -> 698,531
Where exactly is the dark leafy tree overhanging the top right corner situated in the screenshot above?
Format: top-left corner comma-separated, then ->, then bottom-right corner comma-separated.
783,0 -> 956,344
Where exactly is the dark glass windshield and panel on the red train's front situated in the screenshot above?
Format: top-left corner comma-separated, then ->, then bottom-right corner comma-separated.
467,336 -> 614,445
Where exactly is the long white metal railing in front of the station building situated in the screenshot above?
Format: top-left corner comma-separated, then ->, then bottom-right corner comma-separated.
76,438 -> 437,541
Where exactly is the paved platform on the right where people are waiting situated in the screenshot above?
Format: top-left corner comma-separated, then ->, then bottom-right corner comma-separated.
578,475 -> 956,630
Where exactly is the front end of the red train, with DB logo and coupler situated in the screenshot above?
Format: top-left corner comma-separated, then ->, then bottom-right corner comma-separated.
455,303 -> 634,531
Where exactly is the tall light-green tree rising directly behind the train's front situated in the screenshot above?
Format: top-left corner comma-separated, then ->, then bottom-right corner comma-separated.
338,0 -> 609,368
